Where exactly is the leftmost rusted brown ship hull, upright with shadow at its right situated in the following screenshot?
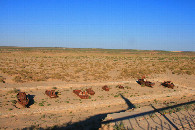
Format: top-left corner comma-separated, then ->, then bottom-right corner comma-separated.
17,92 -> 29,107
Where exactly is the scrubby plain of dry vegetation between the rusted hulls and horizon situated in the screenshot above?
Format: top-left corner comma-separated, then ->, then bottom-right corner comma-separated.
0,48 -> 195,83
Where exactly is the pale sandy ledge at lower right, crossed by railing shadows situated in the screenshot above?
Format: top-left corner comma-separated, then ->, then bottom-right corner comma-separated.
101,104 -> 195,130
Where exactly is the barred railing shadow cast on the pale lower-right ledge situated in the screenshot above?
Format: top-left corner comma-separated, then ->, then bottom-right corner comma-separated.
102,101 -> 195,130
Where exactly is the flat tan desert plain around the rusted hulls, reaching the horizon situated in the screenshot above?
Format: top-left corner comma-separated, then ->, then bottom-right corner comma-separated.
0,47 -> 195,129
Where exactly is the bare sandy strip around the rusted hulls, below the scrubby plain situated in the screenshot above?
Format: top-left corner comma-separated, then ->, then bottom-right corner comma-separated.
0,73 -> 195,129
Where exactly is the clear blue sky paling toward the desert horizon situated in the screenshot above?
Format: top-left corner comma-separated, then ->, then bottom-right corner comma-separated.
0,0 -> 195,51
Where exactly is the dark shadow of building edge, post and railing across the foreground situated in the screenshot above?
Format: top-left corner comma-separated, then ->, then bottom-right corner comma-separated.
24,95 -> 195,130
